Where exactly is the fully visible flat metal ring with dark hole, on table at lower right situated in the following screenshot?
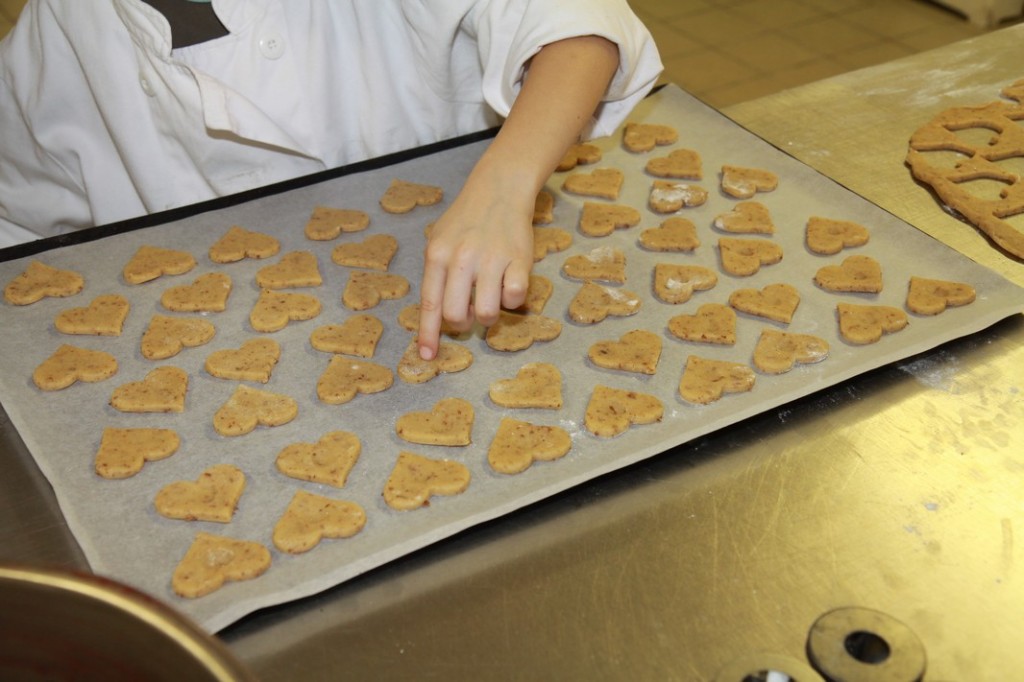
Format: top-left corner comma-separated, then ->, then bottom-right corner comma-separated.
807,606 -> 927,682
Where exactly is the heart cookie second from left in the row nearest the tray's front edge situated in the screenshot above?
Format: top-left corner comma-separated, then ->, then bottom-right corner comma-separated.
273,491 -> 367,554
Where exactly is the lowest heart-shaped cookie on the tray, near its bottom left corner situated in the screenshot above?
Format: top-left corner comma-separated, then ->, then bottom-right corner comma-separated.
171,532 -> 270,599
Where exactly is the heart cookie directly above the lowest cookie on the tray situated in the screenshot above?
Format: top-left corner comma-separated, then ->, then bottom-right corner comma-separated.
154,464 -> 246,523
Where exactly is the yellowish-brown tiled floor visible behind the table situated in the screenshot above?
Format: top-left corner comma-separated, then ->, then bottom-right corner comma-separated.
0,0 -> 1019,108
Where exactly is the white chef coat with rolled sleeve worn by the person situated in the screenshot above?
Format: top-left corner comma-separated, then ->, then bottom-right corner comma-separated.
0,0 -> 662,246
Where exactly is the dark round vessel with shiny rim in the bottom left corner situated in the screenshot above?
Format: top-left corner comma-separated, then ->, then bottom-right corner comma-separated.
0,565 -> 256,682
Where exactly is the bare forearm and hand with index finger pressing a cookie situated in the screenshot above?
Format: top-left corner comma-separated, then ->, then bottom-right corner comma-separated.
419,36 -> 618,359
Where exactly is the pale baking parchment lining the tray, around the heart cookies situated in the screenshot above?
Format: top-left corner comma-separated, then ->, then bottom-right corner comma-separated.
0,87 -> 1022,631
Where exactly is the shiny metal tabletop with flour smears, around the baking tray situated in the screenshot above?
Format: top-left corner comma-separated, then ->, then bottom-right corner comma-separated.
0,27 -> 1024,682
